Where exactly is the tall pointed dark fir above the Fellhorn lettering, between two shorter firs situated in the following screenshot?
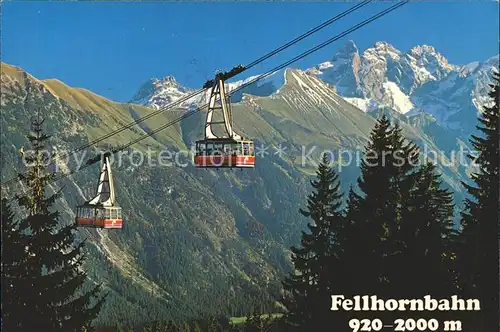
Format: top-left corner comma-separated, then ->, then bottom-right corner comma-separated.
346,115 -> 418,296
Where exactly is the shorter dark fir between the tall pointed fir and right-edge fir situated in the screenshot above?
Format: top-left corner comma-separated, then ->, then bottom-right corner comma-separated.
390,163 -> 456,308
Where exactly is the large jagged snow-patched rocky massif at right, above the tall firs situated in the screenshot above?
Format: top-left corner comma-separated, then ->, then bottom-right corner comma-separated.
308,41 -> 499,132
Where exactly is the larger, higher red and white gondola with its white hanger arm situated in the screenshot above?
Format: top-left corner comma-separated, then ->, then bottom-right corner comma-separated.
194,75 -> 255,168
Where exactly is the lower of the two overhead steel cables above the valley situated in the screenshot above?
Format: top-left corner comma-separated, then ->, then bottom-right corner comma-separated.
6,0 -> 409,189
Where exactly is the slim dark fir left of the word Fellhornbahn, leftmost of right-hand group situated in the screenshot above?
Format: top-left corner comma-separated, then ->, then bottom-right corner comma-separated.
283,154 -> 344,331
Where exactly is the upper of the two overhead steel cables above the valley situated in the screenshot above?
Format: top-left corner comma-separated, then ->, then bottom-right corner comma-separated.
2,0 -> 372,186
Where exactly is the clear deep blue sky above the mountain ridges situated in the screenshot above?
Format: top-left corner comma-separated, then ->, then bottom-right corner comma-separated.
1,1 -> 499,101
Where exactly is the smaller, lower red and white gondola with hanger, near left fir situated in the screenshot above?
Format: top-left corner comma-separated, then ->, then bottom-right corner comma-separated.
75,156 -> 123,228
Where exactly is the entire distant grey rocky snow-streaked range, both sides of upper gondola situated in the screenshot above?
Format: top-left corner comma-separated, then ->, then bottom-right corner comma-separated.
131,41 -> 499,137
